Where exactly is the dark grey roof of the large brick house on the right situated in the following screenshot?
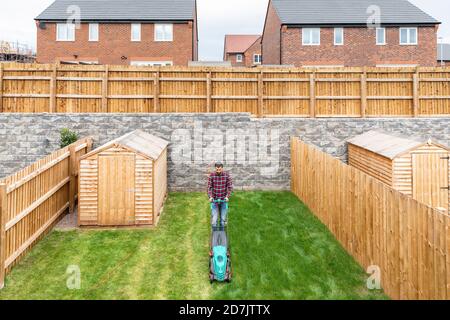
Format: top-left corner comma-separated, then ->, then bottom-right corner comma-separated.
272,0 -> 439,25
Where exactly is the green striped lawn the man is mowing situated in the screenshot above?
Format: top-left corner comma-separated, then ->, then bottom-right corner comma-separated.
0,192 -> 386,299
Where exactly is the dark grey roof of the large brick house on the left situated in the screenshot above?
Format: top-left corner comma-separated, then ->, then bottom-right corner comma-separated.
36,0 -> 196,21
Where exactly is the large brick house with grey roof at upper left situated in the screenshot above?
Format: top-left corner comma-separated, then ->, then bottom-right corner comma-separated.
35,0 -> 198,66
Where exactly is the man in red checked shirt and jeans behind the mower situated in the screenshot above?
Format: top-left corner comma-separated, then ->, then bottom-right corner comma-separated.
208,163 -> 233,227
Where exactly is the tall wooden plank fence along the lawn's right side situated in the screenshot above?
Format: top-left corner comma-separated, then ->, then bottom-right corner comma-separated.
292,138 -> 450,299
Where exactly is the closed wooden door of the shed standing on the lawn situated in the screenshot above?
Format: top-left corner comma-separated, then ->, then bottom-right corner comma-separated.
98,154 -> 135,226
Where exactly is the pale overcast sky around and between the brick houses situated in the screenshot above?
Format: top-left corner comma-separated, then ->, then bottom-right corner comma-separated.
0,0 -> 450,60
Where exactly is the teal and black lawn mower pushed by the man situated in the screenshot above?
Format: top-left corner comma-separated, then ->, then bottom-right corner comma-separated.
209,200 -> 232,283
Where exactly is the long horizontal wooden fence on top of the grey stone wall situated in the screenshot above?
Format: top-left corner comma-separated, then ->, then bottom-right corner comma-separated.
0,64 -> 450,118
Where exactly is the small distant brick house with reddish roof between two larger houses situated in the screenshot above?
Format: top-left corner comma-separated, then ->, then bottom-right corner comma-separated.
223,35 -> 262,67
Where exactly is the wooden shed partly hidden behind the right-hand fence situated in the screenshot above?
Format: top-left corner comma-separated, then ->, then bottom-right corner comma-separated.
348,131 -> 450,212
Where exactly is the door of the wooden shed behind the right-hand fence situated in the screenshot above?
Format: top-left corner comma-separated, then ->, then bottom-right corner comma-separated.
412,153 -> 449,210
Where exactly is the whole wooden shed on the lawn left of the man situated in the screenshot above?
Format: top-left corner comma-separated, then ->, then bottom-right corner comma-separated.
78,130 -> 169,226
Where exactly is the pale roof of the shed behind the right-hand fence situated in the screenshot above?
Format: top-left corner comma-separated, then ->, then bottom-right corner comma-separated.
347,130 -> 448,159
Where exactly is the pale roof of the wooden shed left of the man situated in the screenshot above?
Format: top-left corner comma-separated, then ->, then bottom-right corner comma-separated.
82,130 -> 169,160
